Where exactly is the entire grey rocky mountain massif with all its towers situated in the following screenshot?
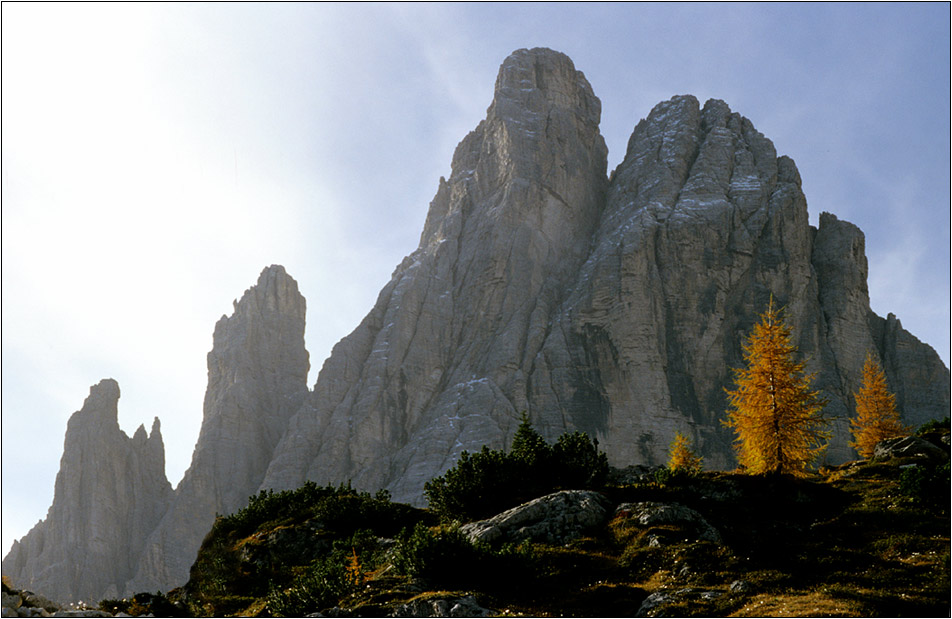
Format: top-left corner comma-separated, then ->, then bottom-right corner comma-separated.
3,49 -> 950,600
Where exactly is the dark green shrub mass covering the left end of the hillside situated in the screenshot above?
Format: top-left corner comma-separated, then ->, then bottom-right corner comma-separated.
186,482 -> 426,614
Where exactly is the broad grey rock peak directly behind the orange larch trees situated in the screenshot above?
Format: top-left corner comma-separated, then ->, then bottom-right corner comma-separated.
531,96 -> 949,468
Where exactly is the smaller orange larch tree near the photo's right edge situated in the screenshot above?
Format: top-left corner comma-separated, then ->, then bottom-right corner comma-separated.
850,353 -> 910,458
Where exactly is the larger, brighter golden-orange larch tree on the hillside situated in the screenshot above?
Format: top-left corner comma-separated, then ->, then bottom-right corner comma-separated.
724,298 -> 830,476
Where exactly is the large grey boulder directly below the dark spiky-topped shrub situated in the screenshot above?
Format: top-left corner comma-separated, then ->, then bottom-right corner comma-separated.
460,490 -> 609,545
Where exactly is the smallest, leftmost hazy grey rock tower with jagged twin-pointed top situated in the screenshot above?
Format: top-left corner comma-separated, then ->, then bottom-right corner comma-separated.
3,379 -> 172,601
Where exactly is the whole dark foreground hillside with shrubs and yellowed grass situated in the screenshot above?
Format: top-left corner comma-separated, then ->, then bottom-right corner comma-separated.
54,422 -> 950,617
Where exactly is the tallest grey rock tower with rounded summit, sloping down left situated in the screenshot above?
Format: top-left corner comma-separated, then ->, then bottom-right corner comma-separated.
263,50 -> 607,499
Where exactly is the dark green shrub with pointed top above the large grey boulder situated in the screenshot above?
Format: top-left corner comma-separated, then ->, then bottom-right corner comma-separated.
424,415 -> 608,521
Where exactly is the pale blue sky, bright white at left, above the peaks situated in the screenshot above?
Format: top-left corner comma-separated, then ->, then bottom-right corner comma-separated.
2,3 -> 950,554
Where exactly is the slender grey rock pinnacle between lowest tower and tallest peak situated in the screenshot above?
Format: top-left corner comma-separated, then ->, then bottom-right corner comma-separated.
127,266 -> 309,593
